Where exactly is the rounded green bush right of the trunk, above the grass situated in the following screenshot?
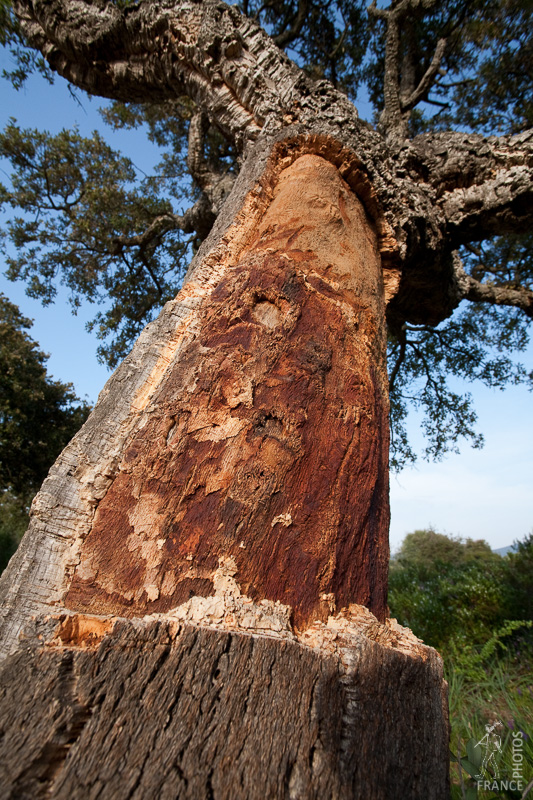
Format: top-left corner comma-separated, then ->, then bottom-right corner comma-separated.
389,530 -> 533,652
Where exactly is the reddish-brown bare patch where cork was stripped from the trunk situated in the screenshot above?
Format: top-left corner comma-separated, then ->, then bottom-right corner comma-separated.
65,155 -> 389,627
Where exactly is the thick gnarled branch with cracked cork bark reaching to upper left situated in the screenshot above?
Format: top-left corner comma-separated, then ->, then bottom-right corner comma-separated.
14,0 -> 300,150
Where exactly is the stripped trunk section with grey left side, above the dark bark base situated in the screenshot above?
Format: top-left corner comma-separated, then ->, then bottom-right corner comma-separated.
2,137 -> 396,651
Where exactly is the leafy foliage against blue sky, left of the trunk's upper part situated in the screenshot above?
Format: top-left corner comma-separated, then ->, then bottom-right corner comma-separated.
0,120 -> 192,366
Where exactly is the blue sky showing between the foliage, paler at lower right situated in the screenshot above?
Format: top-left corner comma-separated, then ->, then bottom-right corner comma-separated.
0,53 -> 533,550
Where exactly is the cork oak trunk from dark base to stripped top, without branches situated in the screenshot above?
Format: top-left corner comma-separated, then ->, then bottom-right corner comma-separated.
0,136 -> 447,798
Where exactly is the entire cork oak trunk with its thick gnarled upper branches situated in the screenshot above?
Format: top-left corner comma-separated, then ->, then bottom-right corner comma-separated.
0,0 -> 533,800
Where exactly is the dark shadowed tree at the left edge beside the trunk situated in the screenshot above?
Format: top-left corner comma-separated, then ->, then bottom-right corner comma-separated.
0,295 -> 89,506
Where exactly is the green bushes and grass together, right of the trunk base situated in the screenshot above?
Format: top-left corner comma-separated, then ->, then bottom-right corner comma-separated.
389,529 -> 533,800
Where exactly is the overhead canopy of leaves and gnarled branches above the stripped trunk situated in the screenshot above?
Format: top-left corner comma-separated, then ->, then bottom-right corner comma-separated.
0,0 -> 533,466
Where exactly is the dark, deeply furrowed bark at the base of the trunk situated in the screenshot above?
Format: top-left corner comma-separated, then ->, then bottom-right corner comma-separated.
0,607 -> 448,800
